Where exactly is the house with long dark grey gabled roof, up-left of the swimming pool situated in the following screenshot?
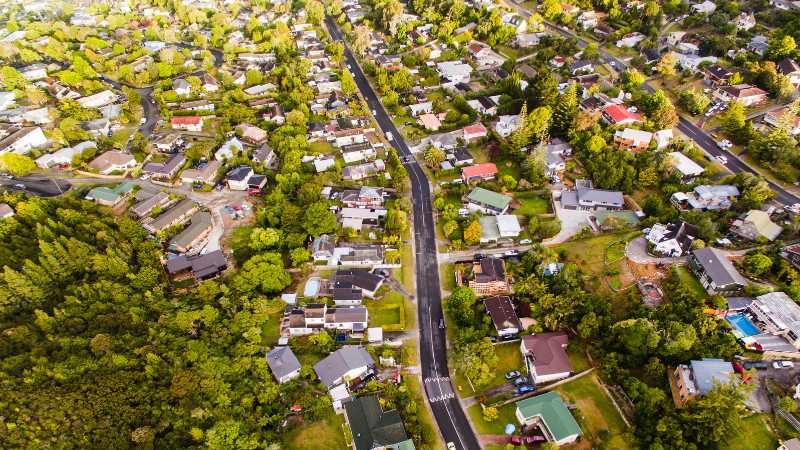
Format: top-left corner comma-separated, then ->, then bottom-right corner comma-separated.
689,248 -> 748,296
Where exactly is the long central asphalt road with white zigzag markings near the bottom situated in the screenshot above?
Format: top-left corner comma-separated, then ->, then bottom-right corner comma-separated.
325,17 -> 480,450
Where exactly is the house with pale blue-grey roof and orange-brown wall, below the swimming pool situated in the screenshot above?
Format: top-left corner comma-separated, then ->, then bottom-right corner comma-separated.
669,358 -> 734,407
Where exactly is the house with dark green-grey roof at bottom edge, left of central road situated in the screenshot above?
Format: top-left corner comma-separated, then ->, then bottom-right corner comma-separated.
344,394 -> 414,450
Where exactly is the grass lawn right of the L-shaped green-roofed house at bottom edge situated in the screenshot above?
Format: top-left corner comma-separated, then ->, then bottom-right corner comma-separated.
555,373 -> 632,449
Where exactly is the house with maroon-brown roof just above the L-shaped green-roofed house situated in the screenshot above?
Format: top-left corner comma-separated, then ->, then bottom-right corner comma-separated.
520,331 -> 572,384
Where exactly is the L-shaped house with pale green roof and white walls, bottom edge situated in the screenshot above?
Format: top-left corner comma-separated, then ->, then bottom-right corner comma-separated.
517,391 -> 581,445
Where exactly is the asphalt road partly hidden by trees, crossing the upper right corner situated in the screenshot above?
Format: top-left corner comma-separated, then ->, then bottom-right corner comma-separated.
507,1 -> 800,205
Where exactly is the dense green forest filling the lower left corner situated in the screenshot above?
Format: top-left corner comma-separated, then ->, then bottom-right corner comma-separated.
0,194 -> 330,449
